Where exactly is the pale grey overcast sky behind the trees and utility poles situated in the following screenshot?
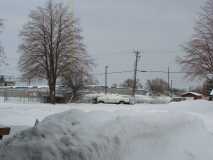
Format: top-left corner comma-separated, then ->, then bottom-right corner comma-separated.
0,0 -> 205,87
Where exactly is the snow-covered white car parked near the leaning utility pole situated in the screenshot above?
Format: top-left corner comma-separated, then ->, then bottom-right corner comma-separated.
96,94 -> 134,104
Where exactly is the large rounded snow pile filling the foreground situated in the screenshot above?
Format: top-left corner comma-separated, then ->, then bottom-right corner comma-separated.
0,110 -> 213,160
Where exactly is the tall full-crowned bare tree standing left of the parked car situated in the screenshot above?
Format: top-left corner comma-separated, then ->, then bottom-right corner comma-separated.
19,0 -> 88,103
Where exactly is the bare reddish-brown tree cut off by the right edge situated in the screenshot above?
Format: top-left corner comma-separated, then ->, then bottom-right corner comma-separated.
178,0 -> 213,78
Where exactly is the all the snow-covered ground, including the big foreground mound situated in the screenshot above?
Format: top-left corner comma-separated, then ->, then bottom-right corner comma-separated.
0,101 -> 213,160
